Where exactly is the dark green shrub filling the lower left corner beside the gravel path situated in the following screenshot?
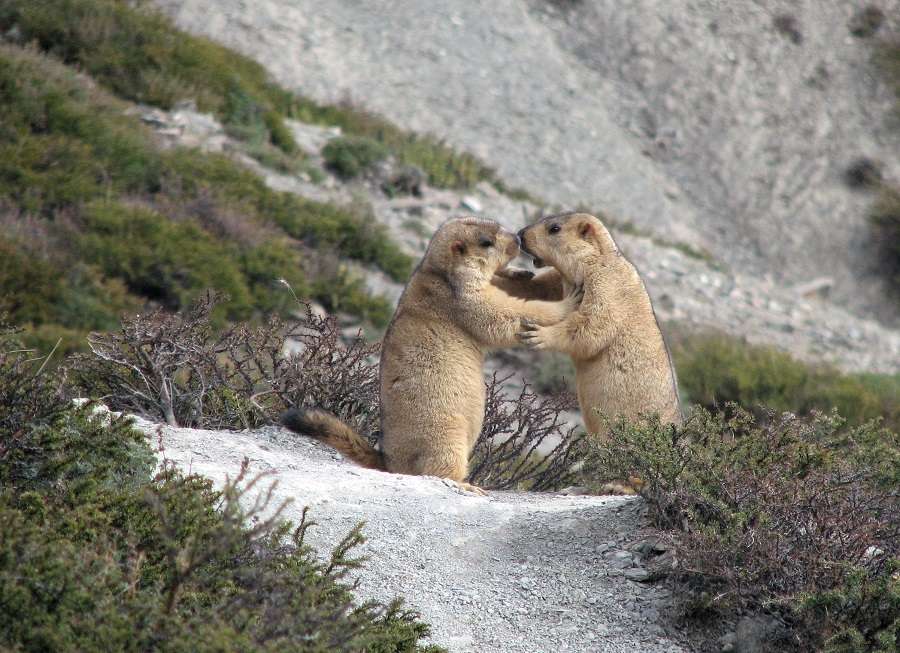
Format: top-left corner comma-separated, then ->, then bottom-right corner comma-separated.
0,322 -> 441,653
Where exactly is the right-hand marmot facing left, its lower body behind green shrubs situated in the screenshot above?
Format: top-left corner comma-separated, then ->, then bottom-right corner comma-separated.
519,213 -> 682,437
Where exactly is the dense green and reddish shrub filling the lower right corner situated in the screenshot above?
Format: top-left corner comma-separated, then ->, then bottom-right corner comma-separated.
585,404 -> 900,653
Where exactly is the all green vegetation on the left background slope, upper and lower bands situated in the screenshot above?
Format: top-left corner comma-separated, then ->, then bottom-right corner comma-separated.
0,0 -> 516,351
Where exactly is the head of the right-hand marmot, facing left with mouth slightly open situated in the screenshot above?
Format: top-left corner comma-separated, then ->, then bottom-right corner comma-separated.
519,213 -> 620,280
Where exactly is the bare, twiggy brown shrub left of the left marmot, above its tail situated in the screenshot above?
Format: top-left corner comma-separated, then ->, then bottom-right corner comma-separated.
71,293 -> 378,430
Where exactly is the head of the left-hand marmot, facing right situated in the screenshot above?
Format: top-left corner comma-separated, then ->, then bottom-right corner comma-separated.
423,217 -> 519,285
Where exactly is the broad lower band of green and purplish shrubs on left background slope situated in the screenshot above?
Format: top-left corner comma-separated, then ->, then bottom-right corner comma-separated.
0,46 -> 411,336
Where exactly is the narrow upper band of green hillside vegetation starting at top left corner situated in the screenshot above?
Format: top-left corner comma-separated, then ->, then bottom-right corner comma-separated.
0,0 -> 502,188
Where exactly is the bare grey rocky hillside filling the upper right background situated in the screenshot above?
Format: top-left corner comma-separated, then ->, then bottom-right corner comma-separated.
156,0 -> 900,324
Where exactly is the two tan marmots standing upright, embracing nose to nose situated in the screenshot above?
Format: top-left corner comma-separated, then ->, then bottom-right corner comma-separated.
282,213 -> 681,489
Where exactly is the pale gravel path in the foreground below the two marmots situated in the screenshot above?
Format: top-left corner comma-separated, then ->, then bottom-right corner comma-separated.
138,420 -> 683,653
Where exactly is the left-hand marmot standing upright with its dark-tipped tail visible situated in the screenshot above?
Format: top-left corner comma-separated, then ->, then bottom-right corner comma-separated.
282,217 -> 580,490
